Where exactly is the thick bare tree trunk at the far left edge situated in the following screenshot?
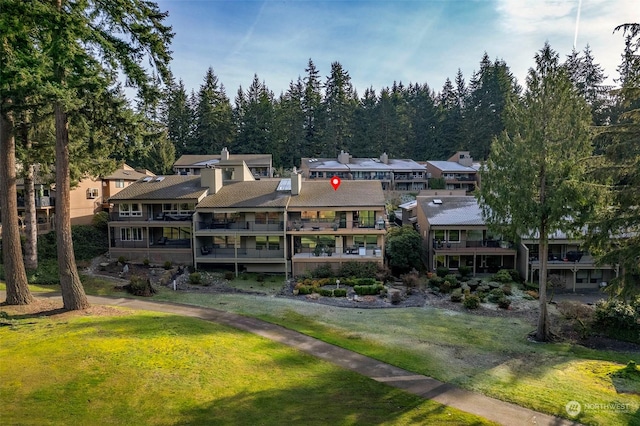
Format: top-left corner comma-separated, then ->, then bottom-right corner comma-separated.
0,108 -> 33,305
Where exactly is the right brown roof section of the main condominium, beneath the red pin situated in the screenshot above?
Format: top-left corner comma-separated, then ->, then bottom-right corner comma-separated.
289,180 -> 384,208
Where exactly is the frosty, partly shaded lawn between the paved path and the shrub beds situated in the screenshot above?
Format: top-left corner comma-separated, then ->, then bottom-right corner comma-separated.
1,280 -> 640,425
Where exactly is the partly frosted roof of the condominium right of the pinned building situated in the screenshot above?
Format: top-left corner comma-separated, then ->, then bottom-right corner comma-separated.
420,196 -> 485,225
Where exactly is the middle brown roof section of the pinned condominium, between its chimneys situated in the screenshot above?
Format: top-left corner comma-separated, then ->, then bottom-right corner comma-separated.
198,180 -> 291,209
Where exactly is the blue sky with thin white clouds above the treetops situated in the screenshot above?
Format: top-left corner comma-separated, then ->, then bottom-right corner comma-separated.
158,0 -> 640,100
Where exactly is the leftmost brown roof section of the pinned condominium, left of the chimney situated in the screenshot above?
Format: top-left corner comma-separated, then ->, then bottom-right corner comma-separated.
109,175 -> 209,201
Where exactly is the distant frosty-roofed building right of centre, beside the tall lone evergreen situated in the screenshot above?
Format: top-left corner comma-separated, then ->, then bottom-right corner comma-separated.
425,151 -> 480,192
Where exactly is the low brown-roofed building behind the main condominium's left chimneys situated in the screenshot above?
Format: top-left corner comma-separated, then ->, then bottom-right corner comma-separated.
173,148 -> 273,181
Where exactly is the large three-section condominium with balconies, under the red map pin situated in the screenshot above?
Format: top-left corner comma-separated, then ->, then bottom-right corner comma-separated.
109,166 -> 386,274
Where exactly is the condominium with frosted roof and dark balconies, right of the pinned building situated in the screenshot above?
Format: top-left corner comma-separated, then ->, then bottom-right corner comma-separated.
416,196 -> 517,275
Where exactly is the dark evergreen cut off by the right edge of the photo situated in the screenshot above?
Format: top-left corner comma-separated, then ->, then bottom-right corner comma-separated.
588,24 -> 640,299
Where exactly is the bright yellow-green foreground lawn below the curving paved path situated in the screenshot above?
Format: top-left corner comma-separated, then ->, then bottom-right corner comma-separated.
0,306 -> 490,425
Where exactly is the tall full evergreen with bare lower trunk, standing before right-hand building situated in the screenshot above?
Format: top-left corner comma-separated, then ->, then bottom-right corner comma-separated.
478,44 -> 597,341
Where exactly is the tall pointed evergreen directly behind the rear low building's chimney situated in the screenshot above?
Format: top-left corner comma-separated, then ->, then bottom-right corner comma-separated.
191,68 -> 233,154
